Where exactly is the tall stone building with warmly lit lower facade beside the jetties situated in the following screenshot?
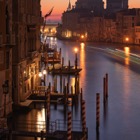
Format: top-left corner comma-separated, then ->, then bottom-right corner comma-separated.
12,0 -> 43,106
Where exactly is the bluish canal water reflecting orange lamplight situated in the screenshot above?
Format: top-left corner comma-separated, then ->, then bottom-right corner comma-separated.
11,38 -> 140,140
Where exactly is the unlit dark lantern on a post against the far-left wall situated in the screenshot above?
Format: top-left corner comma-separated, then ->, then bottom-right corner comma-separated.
2,80 -> 9,117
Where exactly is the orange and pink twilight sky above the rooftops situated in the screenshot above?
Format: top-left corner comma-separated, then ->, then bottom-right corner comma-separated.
41,0 -> 140,21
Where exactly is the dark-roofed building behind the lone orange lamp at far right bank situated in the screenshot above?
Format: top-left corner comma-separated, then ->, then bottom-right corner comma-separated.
116,8 -> 140,44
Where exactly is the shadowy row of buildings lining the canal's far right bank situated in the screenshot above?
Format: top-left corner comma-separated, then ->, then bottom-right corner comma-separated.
57,0 -> 140,44
